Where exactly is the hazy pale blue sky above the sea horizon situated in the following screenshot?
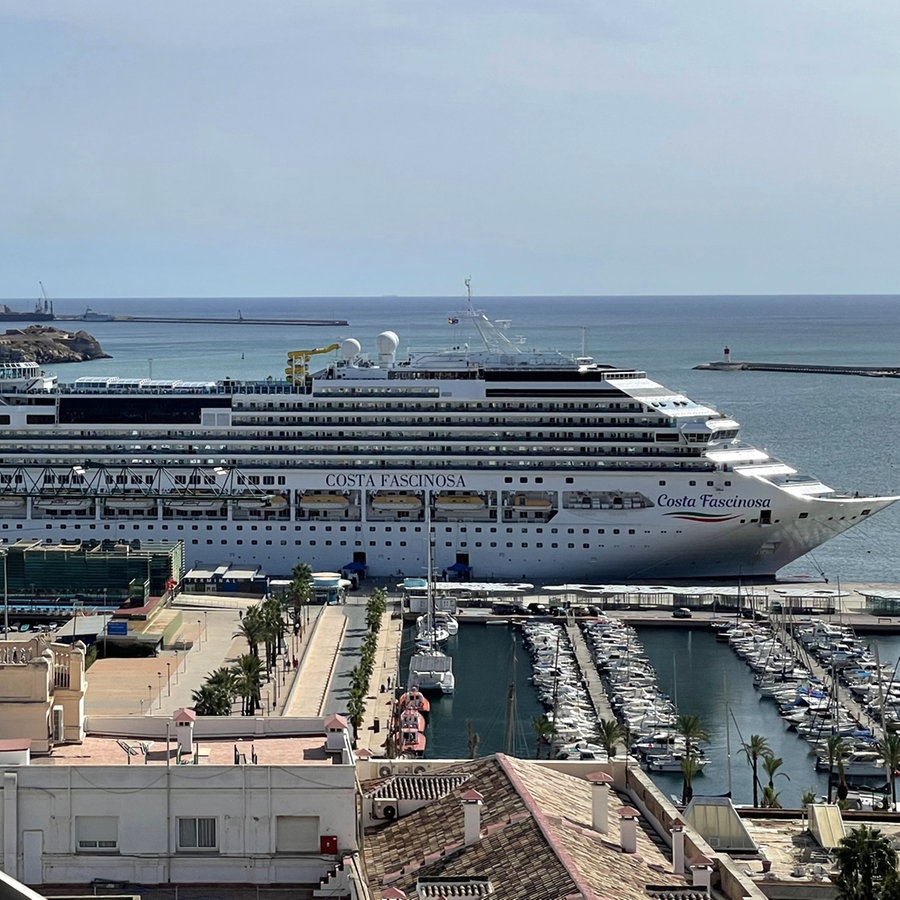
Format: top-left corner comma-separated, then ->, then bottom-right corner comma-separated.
0,0 -> 900,300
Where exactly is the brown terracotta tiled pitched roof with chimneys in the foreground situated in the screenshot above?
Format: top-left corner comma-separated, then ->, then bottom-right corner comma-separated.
364,754 -> 686,900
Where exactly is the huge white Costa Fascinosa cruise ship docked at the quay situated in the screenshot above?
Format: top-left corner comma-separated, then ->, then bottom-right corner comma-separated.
0,297 -> 897,583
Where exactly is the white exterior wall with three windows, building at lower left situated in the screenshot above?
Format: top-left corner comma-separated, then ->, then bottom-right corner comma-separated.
0,763 -> 357,884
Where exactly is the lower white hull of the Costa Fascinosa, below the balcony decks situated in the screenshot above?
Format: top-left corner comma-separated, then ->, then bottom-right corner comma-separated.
0,472 -> 892,583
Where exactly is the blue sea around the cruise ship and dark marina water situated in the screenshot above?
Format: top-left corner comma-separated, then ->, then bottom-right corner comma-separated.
45,296 -> 900,803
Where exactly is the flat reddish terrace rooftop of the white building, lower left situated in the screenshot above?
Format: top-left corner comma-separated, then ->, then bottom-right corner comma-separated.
31,729 -> 341,766
